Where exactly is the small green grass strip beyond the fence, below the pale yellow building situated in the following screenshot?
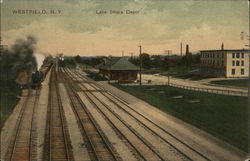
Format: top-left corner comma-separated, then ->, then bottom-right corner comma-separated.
210,79 -> 249,87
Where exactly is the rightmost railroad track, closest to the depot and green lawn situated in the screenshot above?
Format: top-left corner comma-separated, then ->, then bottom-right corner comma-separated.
66,68 -> 210,161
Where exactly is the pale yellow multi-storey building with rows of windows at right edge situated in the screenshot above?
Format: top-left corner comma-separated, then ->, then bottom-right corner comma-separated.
200,44 -> 249,78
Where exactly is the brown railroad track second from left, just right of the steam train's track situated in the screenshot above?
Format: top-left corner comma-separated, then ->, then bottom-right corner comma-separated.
44,68 -> 74,161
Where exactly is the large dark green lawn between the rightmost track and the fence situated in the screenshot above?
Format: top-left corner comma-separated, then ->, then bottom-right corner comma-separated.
114,84 -> 249,152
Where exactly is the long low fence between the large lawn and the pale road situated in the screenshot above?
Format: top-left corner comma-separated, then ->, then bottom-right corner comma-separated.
122,82 -> 248,97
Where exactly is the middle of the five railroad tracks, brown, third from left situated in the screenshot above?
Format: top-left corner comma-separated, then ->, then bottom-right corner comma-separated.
61,68 -> 121,161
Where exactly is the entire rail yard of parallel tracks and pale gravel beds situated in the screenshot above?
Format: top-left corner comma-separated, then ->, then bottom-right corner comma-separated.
1,63 -> 247,161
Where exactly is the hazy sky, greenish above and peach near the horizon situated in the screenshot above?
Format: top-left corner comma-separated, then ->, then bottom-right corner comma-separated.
1,0 -> 249,56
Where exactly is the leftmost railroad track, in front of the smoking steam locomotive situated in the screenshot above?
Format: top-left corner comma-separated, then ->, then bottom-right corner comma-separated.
5,90 -> 40,161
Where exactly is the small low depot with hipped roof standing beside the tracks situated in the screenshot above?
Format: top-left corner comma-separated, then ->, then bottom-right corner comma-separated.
98,57 -> 139,83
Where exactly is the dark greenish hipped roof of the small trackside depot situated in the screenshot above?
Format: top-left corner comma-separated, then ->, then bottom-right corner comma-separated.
99,57 -> 139,70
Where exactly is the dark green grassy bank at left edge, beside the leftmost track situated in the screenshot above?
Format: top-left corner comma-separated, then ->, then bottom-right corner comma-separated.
0,81 -> 21,129
